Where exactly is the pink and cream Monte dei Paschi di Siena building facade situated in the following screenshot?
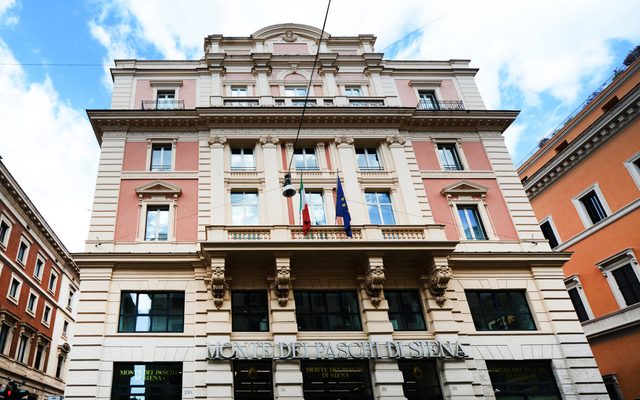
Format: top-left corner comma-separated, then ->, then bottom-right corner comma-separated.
65,24 -> 606,400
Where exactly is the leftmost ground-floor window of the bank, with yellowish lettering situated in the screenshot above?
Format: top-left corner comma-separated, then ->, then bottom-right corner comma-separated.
111,363 -> 182,400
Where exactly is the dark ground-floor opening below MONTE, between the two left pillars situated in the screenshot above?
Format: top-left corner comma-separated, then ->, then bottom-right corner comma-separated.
233,360 -> 273,400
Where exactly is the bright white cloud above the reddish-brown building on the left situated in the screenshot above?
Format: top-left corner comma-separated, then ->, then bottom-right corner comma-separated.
0,40 -> 99,251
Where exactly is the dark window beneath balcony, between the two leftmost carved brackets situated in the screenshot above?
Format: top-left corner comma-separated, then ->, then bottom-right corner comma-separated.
231,291 -> 269,332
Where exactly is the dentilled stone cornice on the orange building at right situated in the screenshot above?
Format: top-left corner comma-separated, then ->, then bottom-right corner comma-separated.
524,86 -> 640,199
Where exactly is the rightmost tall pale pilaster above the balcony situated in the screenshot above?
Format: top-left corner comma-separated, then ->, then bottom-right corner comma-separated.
387,135 -> 425,224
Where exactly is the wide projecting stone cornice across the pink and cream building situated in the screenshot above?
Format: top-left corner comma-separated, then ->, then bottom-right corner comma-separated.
87,107 -> 518,142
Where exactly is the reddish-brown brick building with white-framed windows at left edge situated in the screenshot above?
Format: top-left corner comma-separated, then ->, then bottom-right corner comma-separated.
0,161 -> 80,399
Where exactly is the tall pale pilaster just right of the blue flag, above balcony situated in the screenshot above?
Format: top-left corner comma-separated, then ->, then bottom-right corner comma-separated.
335,136 -> 369,225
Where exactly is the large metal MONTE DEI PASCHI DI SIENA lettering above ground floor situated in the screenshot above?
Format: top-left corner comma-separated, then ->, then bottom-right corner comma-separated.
208,340 -> 469,360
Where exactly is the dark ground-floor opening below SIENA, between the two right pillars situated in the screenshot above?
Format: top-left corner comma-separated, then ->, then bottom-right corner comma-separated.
398,360 -> 442,400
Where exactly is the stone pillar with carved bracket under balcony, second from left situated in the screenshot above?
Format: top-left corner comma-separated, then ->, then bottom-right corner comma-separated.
269,253 -> 303,400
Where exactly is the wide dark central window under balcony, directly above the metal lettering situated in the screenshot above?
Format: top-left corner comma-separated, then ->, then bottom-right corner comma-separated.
294,291 -> 362,331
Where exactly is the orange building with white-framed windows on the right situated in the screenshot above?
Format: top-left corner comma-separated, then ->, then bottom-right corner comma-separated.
518,51 -> 640,399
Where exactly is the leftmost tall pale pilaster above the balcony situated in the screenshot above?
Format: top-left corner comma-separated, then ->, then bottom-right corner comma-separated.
209,134 -> 227,225
